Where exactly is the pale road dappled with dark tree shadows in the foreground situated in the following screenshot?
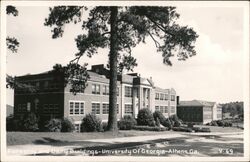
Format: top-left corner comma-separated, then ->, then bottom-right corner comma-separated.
30,135 -> 244,157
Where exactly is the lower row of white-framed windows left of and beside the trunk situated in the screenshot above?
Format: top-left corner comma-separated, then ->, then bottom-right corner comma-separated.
69,101 -> 119,115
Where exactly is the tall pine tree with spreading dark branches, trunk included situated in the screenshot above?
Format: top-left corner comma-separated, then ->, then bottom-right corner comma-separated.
44,6 -> 198,131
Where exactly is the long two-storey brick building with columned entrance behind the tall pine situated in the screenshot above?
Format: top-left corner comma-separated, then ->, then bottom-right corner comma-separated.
14,65 -> 176,131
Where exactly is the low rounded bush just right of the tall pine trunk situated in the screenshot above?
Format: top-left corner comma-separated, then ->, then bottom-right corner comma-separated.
118,115 -> 136,130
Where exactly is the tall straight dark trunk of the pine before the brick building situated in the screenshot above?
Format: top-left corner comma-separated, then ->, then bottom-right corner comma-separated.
108,6 -> 118,132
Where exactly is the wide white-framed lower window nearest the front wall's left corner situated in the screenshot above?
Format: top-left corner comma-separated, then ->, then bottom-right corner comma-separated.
69,101 -> 84,115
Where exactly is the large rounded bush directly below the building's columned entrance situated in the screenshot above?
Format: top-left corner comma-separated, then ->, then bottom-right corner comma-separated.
137,108 -> 155,126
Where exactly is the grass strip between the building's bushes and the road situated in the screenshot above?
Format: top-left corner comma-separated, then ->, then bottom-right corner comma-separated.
7,126 -> 242,146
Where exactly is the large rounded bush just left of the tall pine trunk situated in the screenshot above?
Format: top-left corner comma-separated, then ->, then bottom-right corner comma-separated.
81,114 -> 103,132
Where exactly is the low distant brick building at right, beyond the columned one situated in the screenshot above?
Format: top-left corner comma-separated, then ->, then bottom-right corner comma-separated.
177,100 -> 222,124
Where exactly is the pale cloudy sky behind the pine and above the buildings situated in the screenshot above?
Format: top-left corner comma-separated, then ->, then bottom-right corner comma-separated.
6,3 -> 247,105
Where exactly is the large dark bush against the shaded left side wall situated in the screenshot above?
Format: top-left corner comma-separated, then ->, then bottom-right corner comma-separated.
20,113 -> 38,132
